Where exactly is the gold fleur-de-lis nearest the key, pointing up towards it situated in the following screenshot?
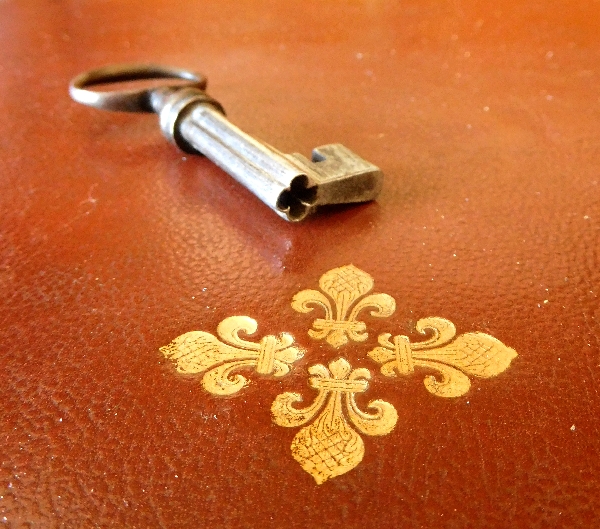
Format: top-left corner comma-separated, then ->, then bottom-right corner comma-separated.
292,265 -> 396,348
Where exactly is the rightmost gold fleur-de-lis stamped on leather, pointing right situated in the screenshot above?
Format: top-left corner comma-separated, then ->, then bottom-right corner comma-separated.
367,318 -> 517,397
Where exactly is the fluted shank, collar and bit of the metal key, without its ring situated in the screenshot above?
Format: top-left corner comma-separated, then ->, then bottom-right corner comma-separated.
153,88 -> 383,222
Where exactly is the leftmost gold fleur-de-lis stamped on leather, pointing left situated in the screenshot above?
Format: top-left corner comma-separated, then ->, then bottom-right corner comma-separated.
160,316 -> 304,395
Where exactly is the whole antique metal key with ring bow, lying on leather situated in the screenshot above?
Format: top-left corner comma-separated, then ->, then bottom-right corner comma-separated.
69,64 -> 383,222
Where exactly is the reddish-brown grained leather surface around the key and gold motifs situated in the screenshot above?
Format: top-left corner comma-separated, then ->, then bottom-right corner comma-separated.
0,0 -> 600,528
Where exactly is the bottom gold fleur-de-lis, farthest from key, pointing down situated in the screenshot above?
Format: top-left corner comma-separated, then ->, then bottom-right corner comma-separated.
271,358 -> 398,485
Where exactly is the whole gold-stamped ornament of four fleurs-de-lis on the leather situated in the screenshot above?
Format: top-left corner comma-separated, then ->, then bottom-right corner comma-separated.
160,265 -> 517,485
